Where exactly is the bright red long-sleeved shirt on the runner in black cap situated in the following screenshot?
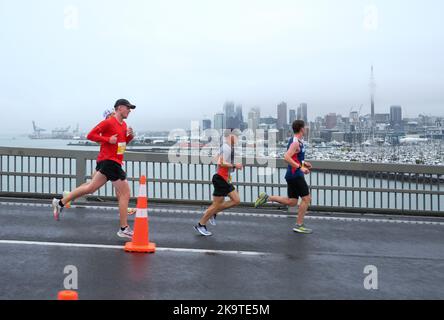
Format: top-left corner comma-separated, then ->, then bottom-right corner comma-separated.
87,117 -> 134,165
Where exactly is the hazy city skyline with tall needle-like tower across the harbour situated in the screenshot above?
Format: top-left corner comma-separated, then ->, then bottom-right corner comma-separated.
195,99 -> 444,145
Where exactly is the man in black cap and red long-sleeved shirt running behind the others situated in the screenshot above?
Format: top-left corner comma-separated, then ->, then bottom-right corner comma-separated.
52,99 -> 136,238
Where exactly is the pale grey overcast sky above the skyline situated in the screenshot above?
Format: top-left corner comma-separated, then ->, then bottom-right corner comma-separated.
0,0 -> 444,133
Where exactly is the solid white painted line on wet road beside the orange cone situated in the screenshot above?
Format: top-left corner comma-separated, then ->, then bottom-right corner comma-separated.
0,240 -> 270,256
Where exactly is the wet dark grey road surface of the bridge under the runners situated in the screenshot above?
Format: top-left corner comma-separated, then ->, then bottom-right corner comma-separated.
0,200 -> 444,300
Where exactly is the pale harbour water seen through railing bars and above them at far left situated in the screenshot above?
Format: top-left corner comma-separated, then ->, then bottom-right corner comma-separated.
0,135 -> 444,211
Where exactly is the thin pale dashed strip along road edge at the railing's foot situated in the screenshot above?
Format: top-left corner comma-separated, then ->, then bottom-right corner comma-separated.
0,202 -> 444,226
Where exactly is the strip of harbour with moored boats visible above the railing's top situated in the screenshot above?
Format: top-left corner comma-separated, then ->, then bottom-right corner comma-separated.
0,135 -> 444,166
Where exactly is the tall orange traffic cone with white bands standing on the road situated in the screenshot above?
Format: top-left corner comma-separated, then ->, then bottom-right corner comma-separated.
125,176 -> 156,252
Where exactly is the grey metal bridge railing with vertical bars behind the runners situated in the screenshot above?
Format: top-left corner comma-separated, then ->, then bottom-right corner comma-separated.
0,147 -> 444,215
